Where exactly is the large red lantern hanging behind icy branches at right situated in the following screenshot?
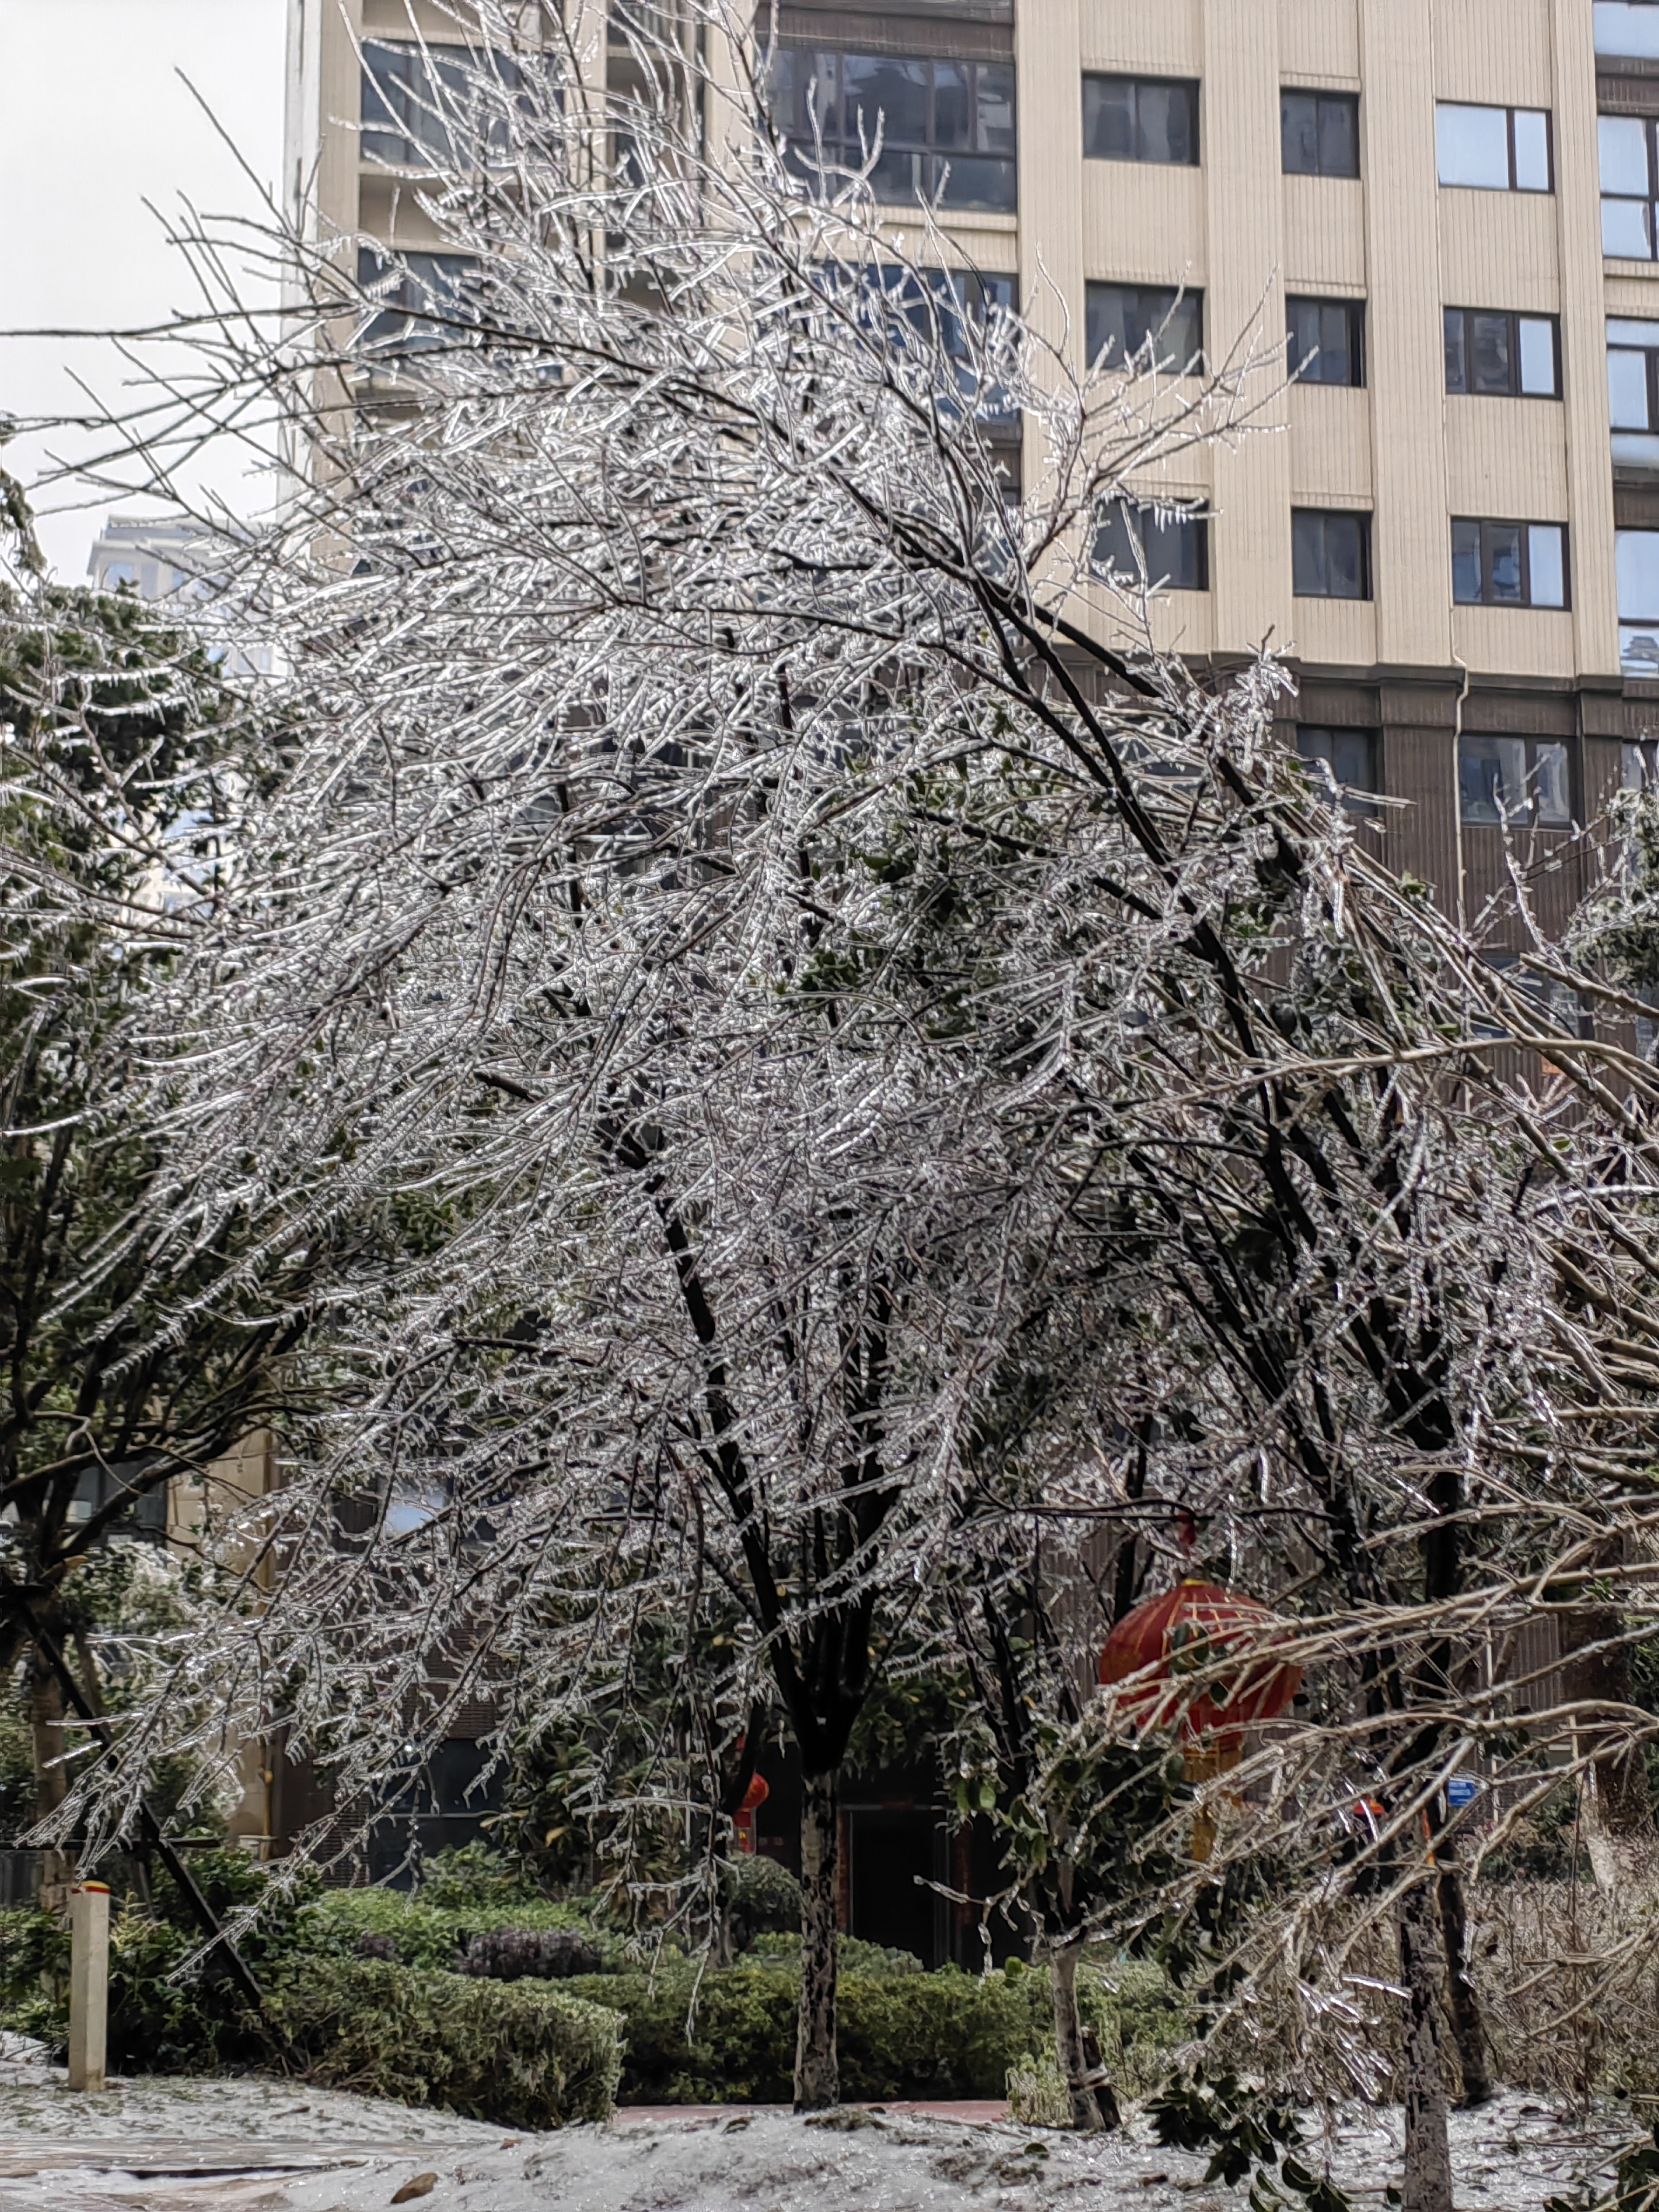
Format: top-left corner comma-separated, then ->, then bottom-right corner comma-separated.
1100,1582 -> 1303,1743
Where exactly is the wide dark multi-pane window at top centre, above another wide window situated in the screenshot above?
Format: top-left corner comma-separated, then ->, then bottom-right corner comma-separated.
770,46 -> 1017,214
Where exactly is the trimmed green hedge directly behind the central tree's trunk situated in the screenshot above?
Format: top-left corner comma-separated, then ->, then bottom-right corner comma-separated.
559,1966 -> 1112,2103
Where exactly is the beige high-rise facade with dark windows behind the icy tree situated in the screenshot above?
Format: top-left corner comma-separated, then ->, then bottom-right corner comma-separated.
287,0 -> 1659,922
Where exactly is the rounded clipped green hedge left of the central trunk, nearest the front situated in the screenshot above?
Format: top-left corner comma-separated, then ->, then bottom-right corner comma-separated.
266,1958 -> 622,2128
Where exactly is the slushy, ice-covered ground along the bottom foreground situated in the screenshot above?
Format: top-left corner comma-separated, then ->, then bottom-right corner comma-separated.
0,2044 -> 1626,2212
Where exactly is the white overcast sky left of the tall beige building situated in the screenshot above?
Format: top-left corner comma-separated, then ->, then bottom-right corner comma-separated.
0,0 -> 285,582
